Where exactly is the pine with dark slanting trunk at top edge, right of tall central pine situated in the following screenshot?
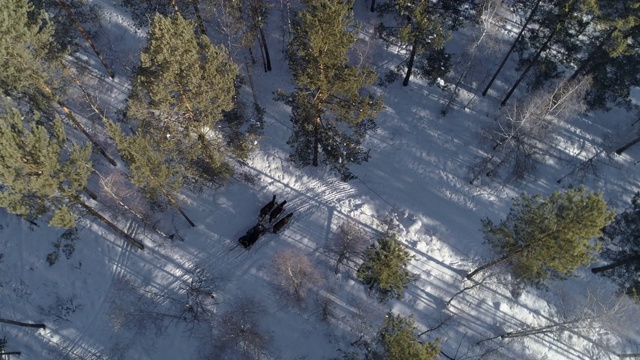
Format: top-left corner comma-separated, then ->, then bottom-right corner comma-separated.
377,0 -> 449,86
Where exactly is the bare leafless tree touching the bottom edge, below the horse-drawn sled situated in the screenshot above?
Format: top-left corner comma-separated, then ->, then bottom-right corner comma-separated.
213,299 -> 269,359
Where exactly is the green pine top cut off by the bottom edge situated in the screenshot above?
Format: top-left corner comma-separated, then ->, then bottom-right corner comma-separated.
367,312 -> 440,360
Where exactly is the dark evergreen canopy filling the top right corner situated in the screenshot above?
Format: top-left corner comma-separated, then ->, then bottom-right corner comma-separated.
508,0 -> 640,110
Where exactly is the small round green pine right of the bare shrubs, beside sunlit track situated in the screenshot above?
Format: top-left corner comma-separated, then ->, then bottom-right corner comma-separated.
358,234 -> 415,301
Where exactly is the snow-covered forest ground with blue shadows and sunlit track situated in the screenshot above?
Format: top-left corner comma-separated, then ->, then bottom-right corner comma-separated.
0,1 -> 640,360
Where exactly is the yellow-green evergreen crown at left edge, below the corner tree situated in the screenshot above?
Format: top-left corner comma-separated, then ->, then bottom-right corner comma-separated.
0,106 -> 91,228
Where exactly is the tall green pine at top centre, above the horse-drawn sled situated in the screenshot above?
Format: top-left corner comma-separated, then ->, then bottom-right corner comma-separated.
277,0 -> 382,180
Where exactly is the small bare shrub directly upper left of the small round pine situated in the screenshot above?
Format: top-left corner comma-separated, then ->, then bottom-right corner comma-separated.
327,220 -> 367,274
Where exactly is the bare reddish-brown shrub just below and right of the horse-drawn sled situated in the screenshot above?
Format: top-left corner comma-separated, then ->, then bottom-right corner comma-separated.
272,250 -> 322,305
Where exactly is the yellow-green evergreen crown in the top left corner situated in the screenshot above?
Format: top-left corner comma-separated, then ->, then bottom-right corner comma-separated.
0,0 -> 62,110
